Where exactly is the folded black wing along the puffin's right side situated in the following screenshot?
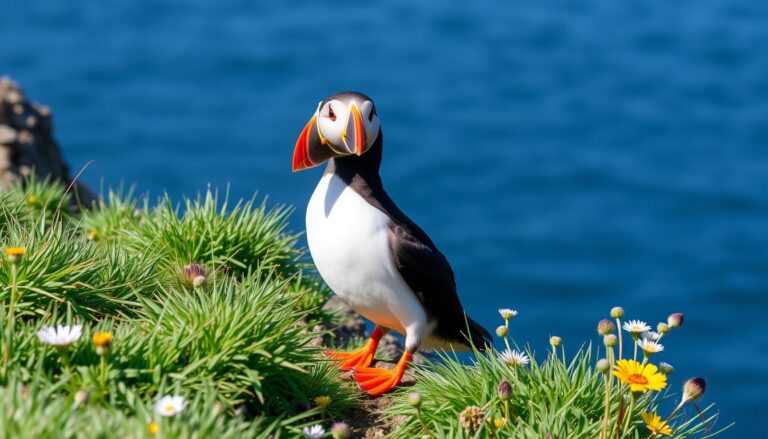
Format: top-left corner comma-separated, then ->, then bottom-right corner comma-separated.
389,223 -> 491,349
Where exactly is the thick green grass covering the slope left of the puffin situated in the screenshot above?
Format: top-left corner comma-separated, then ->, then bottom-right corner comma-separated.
0,178 -> 359,438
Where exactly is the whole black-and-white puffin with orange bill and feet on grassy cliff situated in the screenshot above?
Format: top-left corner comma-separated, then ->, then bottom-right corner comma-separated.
292,92 -> 491,396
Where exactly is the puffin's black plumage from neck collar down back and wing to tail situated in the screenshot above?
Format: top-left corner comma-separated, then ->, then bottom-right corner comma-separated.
325,131 -> 491,349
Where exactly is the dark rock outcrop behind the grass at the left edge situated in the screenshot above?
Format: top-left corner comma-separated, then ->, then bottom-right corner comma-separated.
0,77 -> 96,206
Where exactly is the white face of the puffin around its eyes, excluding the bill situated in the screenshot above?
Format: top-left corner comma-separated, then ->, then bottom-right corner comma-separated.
317,100 -> 381,154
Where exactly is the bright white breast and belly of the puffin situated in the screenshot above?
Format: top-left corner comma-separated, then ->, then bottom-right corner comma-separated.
307,174 -> 427,336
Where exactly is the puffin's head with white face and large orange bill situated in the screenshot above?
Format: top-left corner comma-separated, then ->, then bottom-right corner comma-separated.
293,92 -> 381,172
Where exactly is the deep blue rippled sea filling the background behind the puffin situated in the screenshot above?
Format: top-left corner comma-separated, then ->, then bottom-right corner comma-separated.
0,0 -> 768,438
